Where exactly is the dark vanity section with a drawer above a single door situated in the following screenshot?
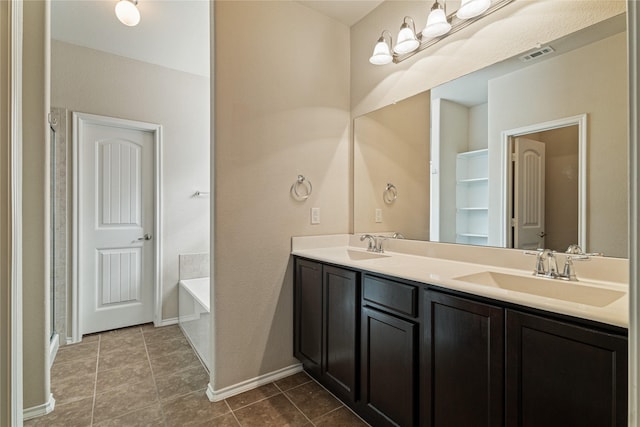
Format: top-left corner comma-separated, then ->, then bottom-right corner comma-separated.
360,275 -> 419,427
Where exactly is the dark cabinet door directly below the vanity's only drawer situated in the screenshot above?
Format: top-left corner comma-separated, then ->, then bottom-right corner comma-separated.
361,307 -> 418,427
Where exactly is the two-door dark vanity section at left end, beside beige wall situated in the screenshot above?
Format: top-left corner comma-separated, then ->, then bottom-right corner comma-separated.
294,259 -> 360,402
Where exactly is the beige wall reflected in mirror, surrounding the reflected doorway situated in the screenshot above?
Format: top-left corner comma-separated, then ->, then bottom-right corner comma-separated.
489,33 -> 628,257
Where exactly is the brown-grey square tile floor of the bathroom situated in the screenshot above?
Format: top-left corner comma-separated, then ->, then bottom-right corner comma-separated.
24,325 -> 366,427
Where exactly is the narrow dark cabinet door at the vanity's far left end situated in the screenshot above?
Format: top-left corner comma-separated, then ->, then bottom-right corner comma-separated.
294,259 -> 322,376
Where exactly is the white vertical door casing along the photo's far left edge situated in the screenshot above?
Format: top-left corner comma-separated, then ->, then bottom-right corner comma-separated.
0,1 -> 23,427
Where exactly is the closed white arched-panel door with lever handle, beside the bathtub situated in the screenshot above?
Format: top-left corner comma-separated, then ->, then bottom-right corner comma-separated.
78,121 -> 155,334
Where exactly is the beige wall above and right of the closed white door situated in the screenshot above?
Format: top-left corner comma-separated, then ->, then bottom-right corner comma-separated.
51,40 -> 210,320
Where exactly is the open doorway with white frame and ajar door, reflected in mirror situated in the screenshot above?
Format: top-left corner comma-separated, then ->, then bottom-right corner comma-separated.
502,114 -> 587,252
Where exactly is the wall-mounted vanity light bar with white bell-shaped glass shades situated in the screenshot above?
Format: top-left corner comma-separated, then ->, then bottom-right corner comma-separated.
369,0 -> 515,65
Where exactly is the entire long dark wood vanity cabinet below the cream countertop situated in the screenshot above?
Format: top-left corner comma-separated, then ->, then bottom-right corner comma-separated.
294,258 -> 627,427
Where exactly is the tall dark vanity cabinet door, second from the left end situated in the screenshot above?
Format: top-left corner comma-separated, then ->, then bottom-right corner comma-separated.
322,266 -> 359,401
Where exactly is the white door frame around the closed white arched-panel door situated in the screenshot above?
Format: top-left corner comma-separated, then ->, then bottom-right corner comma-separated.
71,111 -> 162,343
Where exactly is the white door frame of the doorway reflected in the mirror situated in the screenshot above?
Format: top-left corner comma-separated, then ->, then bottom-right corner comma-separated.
499,113 -> 588,251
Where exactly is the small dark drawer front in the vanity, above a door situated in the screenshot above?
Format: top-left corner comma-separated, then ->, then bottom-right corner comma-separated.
362,276 -> 418,317
